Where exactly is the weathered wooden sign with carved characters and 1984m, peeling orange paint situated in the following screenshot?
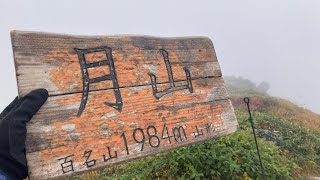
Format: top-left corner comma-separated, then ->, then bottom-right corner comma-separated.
11,31 -> 237,179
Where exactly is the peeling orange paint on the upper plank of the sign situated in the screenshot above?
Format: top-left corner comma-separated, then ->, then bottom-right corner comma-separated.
43,49 -> 213,93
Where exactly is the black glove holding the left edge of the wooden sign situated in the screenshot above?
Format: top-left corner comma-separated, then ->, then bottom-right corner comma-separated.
0,89 -> 48,180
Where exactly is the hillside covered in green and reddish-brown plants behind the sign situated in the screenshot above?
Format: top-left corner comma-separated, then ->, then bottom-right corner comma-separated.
75,77 -> 320,179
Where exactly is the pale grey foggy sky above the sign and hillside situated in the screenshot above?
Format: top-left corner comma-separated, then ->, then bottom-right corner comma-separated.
0,0 -> 320,113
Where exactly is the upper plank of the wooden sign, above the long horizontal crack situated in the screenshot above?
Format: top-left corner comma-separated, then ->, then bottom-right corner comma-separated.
11,32 -> 221,95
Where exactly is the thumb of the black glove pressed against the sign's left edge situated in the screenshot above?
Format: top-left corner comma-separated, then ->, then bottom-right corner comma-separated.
10,89 -> 48,123
